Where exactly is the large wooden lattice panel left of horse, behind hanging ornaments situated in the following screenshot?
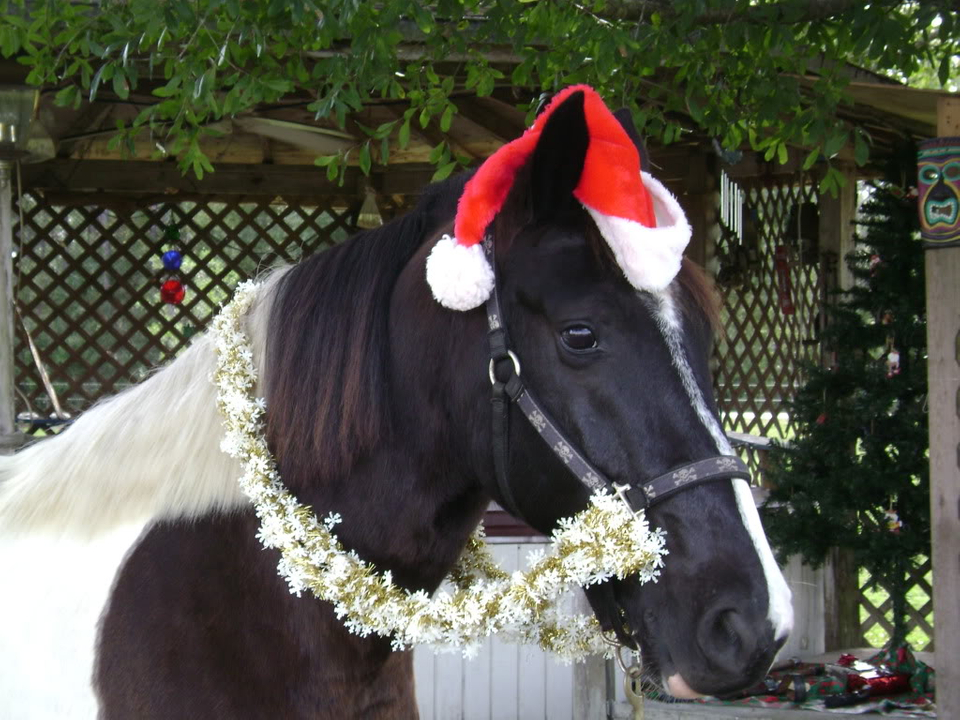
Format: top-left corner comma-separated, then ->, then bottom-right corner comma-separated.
14,188 -> 414,431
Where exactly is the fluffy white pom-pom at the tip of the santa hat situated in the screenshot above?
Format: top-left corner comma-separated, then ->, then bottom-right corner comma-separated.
427,235 -> 494,310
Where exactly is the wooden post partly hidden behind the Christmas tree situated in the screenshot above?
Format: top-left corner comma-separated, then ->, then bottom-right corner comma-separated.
817,166 -> 863,650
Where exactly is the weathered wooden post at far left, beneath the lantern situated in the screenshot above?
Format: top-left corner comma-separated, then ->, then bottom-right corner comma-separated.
0,160 -> 23,454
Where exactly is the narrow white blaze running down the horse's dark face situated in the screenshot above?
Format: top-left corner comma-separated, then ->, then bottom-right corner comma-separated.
652,287 -> 793,640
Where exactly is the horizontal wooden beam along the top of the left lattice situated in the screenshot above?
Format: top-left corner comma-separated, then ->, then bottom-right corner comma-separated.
23,159 -> 434,198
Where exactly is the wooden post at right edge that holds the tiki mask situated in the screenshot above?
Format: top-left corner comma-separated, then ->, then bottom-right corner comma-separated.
926,96 -> 960,718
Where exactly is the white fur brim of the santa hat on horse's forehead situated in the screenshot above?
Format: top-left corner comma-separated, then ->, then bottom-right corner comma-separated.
585,172 -> 691,292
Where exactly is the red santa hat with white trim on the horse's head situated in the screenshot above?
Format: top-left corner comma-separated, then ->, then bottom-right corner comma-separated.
427,85 -> 690,310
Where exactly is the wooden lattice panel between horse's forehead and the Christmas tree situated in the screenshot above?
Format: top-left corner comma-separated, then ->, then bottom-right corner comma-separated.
714,178 -> 825,438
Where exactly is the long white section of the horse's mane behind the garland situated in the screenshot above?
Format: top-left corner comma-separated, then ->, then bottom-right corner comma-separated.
0,273 -> 279,538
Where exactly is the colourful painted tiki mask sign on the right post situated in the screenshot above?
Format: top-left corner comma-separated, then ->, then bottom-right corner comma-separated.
917,137 -> 960,248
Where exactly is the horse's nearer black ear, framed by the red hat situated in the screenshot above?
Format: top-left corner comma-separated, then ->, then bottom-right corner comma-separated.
530,91 -> 590,218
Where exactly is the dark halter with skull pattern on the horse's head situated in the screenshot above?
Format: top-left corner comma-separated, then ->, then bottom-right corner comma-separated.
483,236 -> 750,517
